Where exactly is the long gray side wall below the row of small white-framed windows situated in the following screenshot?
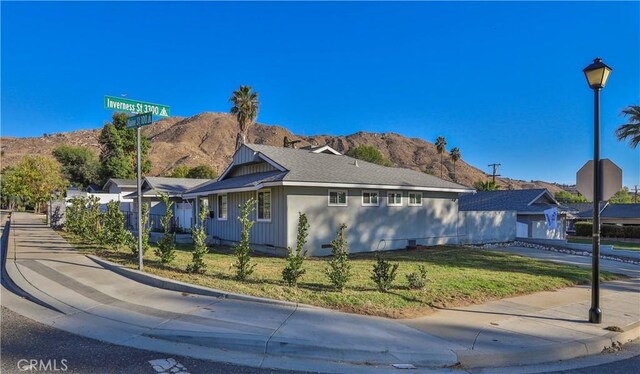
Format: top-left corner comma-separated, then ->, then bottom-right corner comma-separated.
285,187 -> 458,256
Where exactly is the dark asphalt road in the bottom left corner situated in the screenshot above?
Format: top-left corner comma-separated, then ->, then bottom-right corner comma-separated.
0,307 -> 304,374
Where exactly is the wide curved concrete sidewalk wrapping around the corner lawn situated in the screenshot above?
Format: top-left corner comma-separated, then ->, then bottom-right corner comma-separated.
2,213 -> 640,372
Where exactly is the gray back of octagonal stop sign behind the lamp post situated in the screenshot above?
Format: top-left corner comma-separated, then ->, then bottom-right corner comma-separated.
576,158 -> 622,201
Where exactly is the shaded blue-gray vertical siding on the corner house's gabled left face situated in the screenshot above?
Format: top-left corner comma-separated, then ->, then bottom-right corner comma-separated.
207,187 -> 287,255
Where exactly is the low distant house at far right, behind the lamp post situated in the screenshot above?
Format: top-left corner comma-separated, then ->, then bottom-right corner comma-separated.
565,202 -> 640,229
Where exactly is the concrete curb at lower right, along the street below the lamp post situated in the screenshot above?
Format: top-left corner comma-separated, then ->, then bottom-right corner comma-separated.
454,322 -> 640,369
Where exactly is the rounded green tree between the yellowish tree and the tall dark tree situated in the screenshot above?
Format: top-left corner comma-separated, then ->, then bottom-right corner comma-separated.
53,145 -> 100,187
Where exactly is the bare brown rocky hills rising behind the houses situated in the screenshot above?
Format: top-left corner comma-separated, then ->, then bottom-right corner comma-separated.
0,112 -> 563,192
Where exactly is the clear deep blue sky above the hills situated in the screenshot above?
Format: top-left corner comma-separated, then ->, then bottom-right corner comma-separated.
1,2 -> 640,186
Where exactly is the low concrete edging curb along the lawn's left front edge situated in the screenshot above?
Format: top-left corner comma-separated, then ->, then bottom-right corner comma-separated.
86,255 -> 300,308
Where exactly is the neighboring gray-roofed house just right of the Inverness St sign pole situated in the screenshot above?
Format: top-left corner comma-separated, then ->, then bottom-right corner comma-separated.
127,177 -> 211,230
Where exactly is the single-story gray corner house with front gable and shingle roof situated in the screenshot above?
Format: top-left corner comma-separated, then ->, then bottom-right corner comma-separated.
183,144 -> 473,256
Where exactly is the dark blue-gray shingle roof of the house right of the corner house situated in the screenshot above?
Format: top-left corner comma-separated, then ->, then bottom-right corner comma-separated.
458,188 -> 567,214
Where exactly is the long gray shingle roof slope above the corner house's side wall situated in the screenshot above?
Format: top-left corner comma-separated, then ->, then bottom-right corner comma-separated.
240,144 -> 473,191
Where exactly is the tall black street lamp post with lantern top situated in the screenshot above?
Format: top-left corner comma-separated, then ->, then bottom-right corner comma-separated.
582,58 -> 611,323
